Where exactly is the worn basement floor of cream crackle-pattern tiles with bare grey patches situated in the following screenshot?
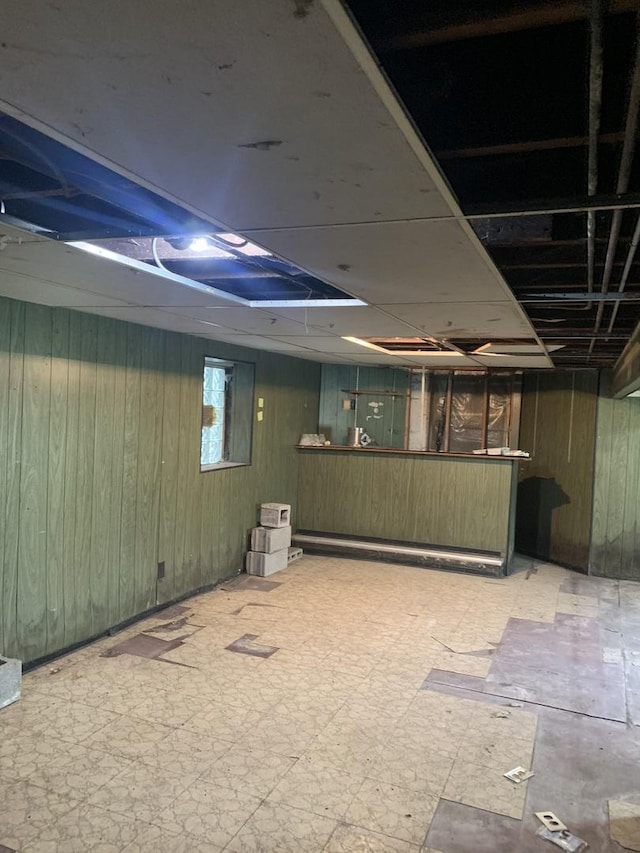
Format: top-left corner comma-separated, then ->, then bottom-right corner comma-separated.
0,557 -> 640,853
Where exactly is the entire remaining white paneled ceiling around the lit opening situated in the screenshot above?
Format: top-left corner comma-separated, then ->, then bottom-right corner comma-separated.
0,0 -> 550,364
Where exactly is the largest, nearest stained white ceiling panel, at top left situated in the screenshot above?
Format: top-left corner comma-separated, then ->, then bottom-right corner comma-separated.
2,0 -> 451,230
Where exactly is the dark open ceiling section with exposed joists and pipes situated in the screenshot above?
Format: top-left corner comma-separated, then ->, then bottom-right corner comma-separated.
347,0 -> 640,367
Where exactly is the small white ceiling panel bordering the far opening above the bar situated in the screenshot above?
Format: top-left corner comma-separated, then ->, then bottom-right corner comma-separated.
384,302 -> 532,340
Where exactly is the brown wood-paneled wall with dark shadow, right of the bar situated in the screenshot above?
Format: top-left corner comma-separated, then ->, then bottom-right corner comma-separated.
516,370 -> 598,572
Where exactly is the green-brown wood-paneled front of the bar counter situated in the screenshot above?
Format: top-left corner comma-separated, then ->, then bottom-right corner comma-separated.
298,450 -> 517,554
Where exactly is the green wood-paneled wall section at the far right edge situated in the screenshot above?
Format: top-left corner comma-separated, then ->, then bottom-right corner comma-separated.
590,396 -> 640,580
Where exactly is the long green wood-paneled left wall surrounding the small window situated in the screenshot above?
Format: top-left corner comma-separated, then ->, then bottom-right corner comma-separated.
0,298 -> 319,661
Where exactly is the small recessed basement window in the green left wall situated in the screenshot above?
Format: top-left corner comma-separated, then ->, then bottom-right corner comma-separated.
200,358 -> 255,471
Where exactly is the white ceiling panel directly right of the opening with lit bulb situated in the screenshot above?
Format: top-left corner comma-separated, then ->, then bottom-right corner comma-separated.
252,220 -> 524,306
